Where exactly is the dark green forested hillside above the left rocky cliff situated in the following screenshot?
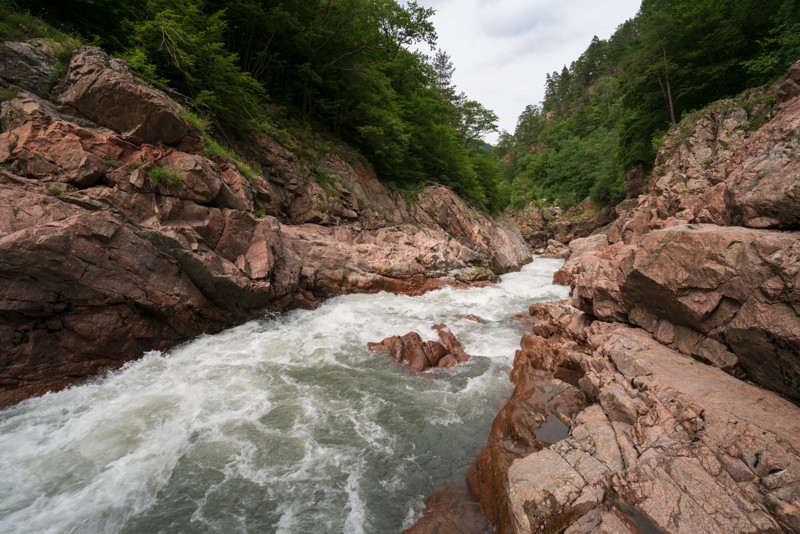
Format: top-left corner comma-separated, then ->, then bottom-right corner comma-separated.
6,0 -> 503,210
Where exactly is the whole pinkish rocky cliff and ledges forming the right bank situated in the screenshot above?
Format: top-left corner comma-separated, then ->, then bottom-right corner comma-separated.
468,63 -> 800,533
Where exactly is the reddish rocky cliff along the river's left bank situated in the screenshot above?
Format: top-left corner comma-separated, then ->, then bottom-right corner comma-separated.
0,41 -> 529,407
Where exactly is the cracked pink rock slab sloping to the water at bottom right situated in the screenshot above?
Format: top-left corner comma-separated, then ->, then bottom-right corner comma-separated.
469,304 -> 800,533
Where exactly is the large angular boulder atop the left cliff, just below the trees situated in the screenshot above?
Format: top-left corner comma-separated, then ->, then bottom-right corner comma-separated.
56,46 -> 193,145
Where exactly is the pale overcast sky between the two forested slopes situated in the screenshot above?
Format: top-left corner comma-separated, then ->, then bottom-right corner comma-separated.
418,0 -> 641,143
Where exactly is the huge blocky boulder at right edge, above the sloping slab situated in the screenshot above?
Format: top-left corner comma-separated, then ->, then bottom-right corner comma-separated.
620,225 -> 800,398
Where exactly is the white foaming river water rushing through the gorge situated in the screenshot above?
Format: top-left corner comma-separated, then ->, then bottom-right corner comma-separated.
0,258 -> 567,533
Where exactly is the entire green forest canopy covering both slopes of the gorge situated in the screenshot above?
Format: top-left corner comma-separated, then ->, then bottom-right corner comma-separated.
7,0 -> 800,212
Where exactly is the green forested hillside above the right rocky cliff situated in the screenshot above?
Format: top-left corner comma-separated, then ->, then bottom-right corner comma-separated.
497,0 -> 800,208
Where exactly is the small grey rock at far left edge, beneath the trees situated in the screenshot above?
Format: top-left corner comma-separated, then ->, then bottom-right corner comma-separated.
0,39 -> 57,97
